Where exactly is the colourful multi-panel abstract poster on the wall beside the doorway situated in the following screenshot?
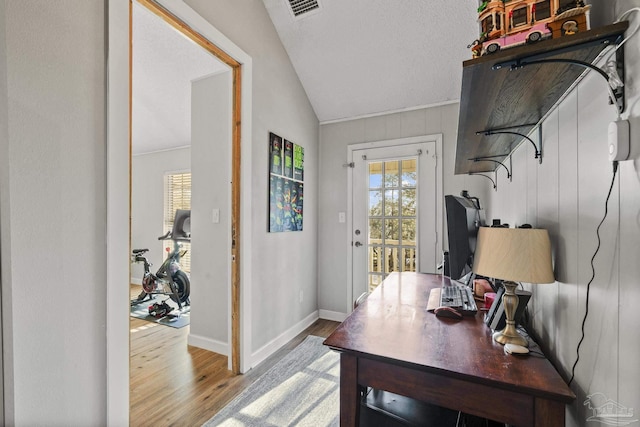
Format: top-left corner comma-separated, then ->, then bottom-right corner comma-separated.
268,132 -> 304,233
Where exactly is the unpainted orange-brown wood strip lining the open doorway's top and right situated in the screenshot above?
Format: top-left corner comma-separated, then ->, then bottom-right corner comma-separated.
135,0 -> 242,374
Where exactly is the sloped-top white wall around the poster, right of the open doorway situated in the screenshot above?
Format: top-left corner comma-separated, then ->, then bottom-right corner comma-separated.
186,0 -> 318,363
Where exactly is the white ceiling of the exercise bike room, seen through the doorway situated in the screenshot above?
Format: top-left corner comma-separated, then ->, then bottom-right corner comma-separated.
132,2 -> 226,154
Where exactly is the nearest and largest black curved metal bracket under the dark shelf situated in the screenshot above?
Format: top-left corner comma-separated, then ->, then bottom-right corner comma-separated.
492,39 -> 626,113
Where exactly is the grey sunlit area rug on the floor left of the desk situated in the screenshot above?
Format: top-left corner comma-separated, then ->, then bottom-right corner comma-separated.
204,335 -> 340,427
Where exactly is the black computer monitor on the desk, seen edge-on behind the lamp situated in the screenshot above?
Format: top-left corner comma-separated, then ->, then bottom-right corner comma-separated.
444,195 -> 485,282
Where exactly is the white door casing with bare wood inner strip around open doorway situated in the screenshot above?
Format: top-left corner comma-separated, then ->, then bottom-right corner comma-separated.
107,0 -> 252,425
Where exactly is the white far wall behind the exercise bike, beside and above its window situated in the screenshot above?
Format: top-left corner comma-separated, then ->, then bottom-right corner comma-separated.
131,147 -> 191,284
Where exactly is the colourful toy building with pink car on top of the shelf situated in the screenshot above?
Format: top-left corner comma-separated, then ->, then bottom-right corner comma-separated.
468,0 -> 591,58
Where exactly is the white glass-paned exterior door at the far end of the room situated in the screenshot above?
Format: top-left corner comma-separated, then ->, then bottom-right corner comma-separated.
350,141 -> 441,301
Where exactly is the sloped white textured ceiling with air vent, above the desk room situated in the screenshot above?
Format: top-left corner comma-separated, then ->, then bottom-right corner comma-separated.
263,0 -> 478,122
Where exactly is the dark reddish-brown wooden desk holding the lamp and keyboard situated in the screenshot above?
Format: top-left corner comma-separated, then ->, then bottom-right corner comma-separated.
324,273 -> 575,427
